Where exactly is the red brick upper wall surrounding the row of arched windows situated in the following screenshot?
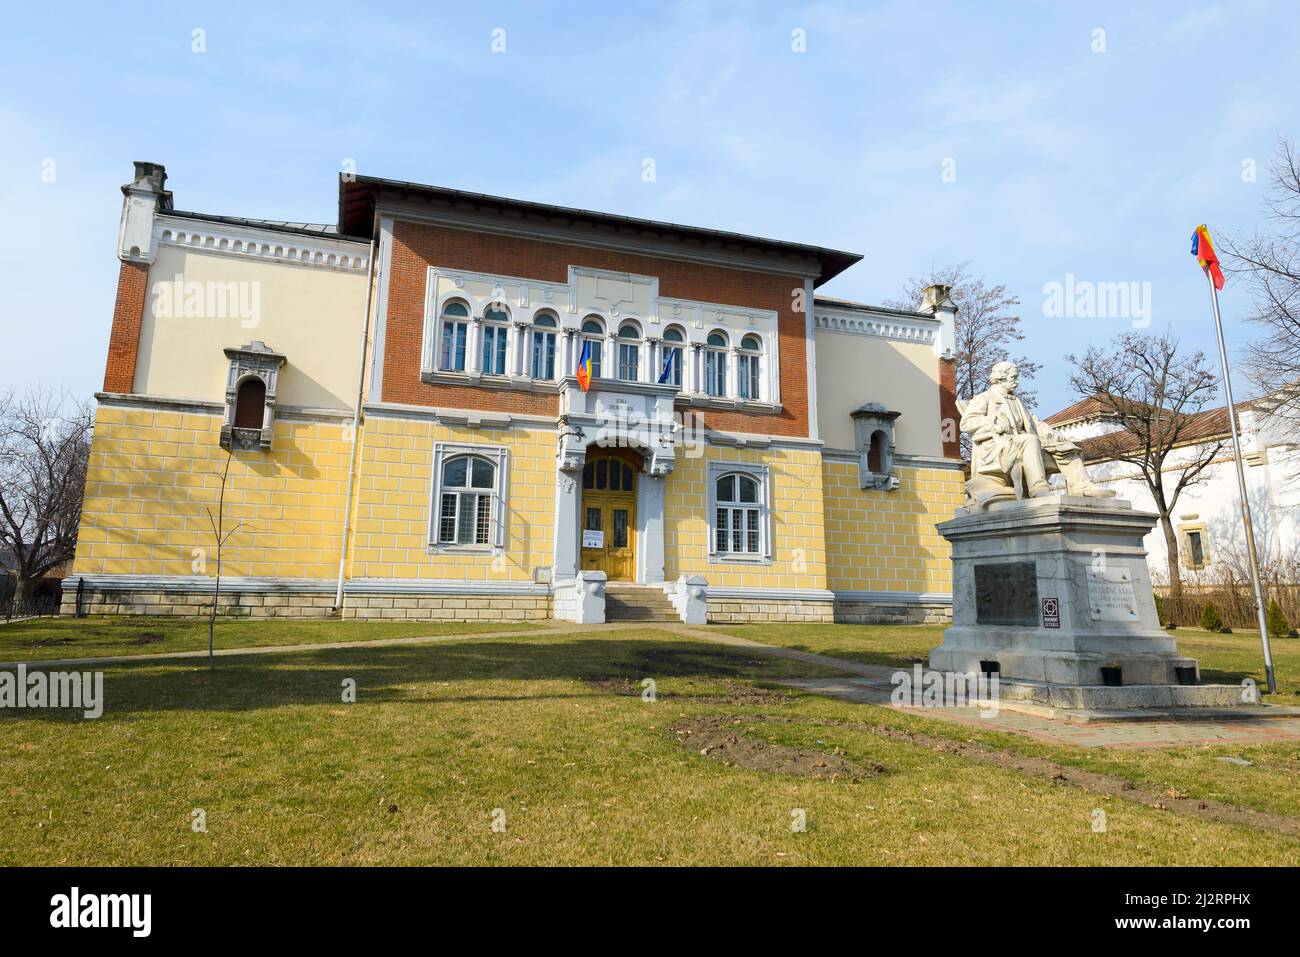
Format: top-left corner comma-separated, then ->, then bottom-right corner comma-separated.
384,222 -> 810,436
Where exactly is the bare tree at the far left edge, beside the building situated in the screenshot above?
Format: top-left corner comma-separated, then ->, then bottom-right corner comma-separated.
0,389 -> 92,605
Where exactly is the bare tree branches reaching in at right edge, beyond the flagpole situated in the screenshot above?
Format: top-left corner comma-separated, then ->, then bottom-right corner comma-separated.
1221,139 -> 1300,412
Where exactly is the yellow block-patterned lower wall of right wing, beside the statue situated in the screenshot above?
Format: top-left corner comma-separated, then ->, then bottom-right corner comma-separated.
823,459 -> 966,593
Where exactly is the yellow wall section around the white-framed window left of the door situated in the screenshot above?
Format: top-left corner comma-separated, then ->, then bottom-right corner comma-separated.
350,416 -> 555,583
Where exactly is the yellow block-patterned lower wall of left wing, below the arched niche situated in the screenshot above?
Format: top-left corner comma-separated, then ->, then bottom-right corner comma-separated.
73,404 -> 350,579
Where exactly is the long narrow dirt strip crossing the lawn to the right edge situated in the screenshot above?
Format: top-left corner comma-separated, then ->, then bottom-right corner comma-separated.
757,715 -> 1300,836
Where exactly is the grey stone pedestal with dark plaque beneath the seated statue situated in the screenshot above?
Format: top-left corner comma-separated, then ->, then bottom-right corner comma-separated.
930,495 -> 1201,707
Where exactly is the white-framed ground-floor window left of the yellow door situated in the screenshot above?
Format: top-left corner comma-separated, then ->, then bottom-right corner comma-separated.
429,443 -> 507,547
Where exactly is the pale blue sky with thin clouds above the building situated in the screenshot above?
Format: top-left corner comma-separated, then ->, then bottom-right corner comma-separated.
0,0 -> 1300,412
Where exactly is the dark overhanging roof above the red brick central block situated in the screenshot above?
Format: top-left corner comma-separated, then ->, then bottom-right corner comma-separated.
338,174 -> 862,283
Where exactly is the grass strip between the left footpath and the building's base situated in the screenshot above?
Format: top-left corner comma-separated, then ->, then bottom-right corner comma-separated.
0,615 -> 532,662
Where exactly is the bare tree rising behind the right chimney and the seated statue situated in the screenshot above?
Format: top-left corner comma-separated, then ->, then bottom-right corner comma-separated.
887,263 -> 1041,406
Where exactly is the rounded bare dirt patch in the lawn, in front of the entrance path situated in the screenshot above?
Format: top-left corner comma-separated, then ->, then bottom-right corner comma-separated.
671,715 -> 885,781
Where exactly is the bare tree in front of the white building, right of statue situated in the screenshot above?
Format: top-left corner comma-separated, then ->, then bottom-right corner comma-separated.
1066,332 -> 1223,597
